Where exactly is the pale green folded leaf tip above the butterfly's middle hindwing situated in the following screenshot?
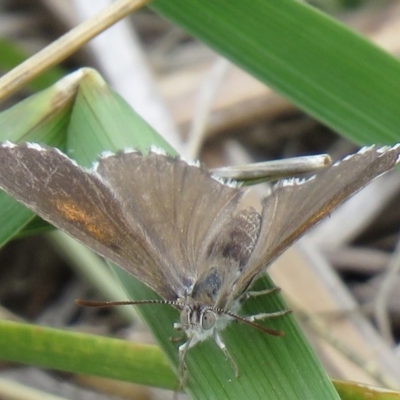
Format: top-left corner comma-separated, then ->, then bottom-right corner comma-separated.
67,69 -> 177,162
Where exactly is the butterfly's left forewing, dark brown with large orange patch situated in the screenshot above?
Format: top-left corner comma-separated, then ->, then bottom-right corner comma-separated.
0,143 -> 188,298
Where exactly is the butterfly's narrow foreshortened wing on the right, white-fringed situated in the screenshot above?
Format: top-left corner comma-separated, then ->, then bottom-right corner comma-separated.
232,145 -> 400,298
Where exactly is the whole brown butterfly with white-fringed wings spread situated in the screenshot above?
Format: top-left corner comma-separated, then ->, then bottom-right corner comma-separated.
0,142 -> 400,375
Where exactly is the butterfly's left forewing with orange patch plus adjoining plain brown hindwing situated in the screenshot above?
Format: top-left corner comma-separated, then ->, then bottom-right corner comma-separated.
0,142 -> 240,300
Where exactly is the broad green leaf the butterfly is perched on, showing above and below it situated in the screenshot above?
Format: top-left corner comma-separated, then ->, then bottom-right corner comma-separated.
65,70 -> 339,400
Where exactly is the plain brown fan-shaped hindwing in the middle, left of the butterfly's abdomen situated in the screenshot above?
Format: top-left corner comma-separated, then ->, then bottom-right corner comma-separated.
96,152 -> 242,296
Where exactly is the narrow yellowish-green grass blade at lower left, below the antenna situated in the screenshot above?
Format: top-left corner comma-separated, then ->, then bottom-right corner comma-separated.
0,321 -> 176,389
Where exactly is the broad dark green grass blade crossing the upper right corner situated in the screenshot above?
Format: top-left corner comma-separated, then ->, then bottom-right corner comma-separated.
152,0 -> 400,143
